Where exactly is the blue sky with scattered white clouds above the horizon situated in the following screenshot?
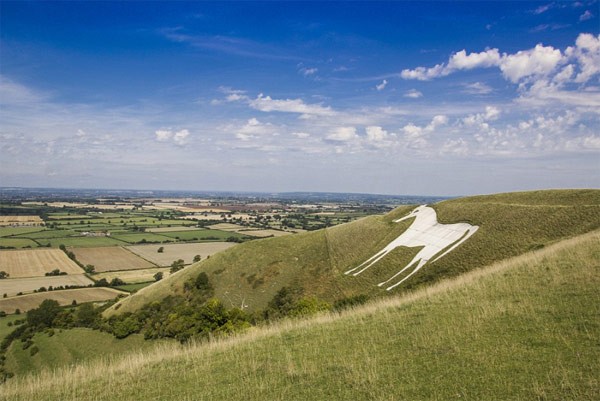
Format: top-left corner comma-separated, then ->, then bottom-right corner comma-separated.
0,1 -> 600,195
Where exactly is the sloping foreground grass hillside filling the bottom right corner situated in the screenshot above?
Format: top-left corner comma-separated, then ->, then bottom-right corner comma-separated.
2,231 -> 600,400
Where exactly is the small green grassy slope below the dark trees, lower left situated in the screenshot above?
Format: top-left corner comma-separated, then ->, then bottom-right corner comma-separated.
6,328 -> 171,375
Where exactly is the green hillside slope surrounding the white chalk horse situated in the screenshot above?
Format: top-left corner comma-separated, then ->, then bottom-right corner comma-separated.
107,190 -> 600,315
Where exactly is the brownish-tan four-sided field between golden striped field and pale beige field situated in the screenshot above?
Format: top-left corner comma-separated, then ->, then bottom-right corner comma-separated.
70,246 -> 156,273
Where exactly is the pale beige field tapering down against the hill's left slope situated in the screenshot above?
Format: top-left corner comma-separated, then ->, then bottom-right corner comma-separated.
127,242 -> 236,266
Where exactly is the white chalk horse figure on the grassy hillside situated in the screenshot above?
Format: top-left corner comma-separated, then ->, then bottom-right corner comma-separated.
345,205 -> 479,291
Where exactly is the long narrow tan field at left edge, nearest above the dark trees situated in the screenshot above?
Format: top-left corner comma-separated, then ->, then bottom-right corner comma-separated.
0,287 -> 128,313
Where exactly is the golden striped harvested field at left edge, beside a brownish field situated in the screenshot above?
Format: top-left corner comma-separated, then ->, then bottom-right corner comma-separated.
0,249 -> 82,278
